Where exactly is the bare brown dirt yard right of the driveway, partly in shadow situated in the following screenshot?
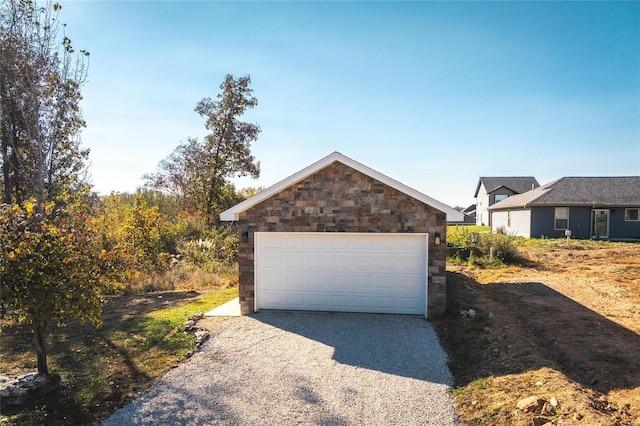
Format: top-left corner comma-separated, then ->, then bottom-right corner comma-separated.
434,242 -> 640,425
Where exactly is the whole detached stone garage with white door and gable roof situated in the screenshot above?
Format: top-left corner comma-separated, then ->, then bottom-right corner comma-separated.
220,152 -> 462,317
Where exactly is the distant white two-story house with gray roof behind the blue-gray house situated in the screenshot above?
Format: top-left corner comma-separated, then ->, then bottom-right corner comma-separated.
474,176 -> 540,226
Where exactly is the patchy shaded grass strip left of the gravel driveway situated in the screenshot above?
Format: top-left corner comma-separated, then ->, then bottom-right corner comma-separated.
0,288 -> 238,425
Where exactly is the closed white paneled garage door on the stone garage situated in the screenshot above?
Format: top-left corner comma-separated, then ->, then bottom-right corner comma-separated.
255,232 -> 428,316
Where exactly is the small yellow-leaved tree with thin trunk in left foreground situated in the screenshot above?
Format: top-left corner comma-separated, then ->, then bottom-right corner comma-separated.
0,197 -> 107,374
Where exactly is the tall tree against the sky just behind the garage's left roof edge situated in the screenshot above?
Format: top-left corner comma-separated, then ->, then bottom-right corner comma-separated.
145,75 -> 260,223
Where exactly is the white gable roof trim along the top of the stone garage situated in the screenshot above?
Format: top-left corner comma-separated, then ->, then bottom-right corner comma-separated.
220,151 -> 464,222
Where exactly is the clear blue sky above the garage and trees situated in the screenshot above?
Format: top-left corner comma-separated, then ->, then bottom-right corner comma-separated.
60,0 -> 640,206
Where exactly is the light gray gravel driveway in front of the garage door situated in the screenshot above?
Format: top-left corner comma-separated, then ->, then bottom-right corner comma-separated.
104,312 -> 457,426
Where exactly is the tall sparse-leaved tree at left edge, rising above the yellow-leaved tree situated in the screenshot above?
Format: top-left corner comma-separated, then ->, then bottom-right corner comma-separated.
0,0 -> 89,204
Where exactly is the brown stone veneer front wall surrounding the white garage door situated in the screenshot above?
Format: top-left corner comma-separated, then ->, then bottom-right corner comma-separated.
238,162 -> 447,318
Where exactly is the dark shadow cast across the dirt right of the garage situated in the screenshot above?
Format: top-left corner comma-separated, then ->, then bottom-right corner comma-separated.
434,272 -> 640,393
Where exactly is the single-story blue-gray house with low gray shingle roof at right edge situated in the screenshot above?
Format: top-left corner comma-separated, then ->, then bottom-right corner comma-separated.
489,176 -> 640,240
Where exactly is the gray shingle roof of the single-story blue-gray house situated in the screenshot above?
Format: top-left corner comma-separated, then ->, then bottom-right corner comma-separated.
489,176 -> 640,210
